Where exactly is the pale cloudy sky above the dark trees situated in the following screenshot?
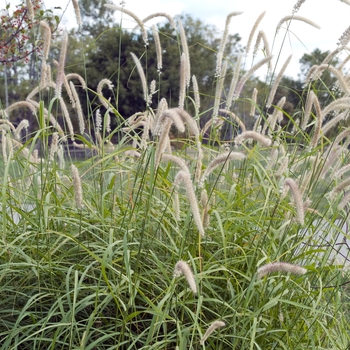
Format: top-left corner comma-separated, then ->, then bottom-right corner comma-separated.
44,0 -> 350,77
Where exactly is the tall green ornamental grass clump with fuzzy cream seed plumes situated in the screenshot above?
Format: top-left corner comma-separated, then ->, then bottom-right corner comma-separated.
0,1 -> 350,350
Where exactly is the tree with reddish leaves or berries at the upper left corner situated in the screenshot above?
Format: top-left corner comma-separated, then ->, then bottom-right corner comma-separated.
0,0 -> 59,107
